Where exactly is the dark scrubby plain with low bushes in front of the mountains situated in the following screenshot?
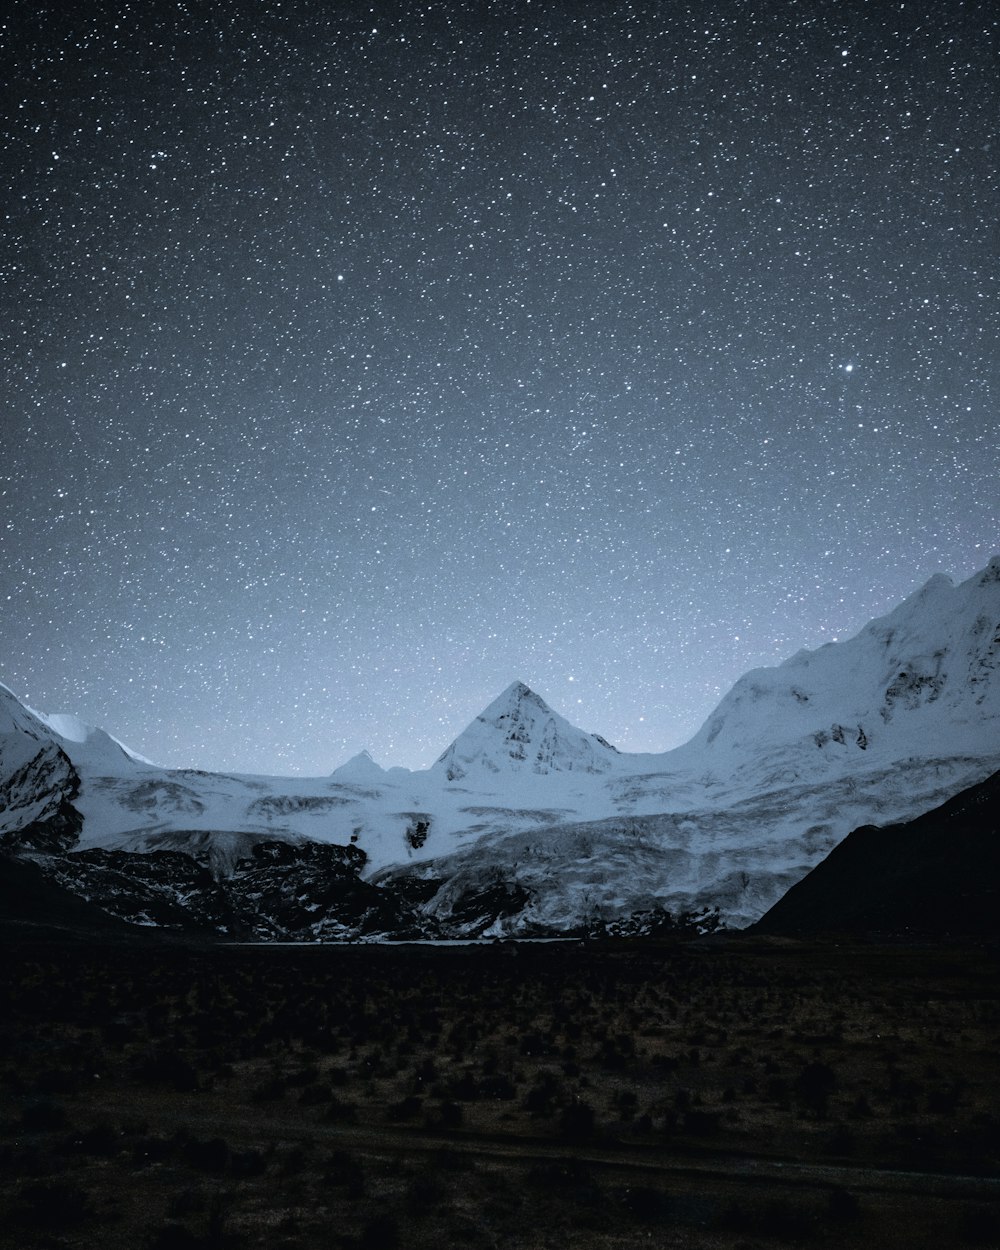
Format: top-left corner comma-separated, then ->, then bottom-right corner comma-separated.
0,926 -> 1000,1250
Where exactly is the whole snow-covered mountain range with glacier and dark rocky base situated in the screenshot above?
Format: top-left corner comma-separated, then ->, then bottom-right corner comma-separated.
0,558 -> 1000,938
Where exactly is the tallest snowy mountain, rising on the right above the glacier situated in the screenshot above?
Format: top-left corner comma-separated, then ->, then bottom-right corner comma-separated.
669,556 -> 1000,780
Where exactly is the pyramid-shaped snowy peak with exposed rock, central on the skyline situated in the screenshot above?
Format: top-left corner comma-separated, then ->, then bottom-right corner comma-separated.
433,681 -> 619,781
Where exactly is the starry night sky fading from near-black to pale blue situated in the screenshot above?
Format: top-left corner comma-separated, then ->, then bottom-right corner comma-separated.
0,0 -> 1000,774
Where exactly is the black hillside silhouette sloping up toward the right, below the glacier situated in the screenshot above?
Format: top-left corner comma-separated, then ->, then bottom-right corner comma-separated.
750,773 -> 1000,938
